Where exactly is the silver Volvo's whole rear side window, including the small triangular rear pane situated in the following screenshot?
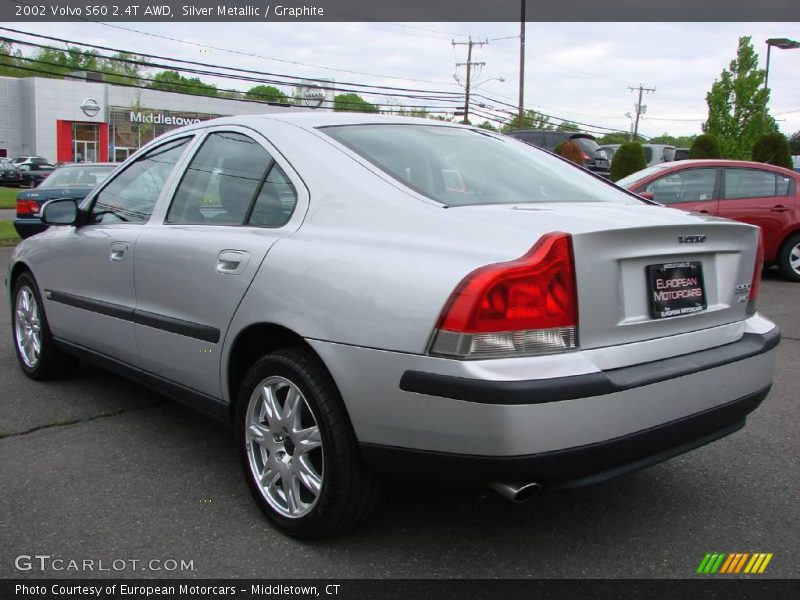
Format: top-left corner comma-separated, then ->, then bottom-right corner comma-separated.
166,131 -> 297,227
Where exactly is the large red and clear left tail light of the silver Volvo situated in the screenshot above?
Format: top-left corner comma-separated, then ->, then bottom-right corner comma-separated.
430,232 -> 578,358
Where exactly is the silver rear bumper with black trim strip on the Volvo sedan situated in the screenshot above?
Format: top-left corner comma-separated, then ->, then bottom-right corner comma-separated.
309,315 -> 780,466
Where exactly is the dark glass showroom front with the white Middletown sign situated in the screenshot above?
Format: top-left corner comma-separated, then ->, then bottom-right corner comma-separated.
108,106 -> 222,162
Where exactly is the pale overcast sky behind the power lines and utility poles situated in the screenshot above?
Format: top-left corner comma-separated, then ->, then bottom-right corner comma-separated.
6,22 -> 800,136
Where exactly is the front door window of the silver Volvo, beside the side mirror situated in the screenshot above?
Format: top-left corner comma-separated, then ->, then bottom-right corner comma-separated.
92,138 -> 191,223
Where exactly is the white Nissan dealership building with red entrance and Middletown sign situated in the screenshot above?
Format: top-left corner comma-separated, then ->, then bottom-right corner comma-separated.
0,77 -> 333,163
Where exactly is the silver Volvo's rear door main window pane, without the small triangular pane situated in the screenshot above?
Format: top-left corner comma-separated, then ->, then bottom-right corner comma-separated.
166,131 -> 274,225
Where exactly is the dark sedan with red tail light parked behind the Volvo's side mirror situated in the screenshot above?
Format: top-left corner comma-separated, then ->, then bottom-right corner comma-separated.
14,163 -> 117,239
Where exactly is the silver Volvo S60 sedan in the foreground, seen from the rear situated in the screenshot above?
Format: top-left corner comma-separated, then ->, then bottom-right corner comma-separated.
8,113 -> 780,538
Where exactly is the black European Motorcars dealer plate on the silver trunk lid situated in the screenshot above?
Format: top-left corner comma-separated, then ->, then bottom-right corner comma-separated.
647,262 -> 707,319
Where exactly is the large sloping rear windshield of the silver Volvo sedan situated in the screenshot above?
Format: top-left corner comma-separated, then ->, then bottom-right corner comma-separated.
320,124 -> 636,206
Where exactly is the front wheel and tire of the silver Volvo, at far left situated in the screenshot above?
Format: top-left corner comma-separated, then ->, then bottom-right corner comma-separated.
11,273 -> 78,381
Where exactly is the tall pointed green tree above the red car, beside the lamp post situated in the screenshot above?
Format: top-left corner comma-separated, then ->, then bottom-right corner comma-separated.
703,36 -> 777,160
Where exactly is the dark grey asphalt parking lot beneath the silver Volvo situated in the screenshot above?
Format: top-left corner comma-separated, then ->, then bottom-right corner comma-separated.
0,248 -> 800,578
